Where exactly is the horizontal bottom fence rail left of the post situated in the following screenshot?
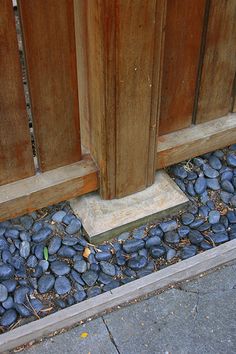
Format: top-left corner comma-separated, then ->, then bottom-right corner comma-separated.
0,156 -> 98,221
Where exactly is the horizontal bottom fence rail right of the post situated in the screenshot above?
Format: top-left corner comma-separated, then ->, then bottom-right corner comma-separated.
156,113 -> 236,169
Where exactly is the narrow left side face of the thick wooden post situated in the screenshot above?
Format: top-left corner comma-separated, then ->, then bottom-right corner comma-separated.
86,0 -> 116,199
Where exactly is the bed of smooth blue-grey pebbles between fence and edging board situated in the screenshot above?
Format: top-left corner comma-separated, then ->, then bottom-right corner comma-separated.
0,144 -> 236,332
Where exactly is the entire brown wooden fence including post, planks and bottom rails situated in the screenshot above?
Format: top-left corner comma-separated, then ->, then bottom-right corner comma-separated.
0,0 -> 236,220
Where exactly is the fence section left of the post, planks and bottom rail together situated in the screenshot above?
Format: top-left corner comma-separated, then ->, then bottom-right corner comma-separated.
0,0 -> 98,219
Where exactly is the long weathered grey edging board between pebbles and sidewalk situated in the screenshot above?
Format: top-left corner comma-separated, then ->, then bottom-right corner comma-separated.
0,239 -> 236,352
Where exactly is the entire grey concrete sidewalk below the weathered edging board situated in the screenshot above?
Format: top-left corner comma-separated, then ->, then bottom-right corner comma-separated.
23,262 -> 236,354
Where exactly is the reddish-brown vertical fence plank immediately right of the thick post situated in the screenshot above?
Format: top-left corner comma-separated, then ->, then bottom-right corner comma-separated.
159,0 -> 206,135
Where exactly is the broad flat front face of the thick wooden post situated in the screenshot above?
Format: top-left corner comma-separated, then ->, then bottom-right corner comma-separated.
116,0 -> 158,196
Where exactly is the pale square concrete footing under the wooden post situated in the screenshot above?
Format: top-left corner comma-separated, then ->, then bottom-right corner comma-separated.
70,171 -> 188,243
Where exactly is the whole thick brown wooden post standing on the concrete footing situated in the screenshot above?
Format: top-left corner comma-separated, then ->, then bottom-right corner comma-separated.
74,0 -> 166,199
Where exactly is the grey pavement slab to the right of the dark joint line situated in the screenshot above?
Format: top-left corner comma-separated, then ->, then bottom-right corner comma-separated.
104,264 -> 236,354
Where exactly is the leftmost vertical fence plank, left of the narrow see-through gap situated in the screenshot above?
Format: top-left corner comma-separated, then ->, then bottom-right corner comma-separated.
0,0 -> 34,185
